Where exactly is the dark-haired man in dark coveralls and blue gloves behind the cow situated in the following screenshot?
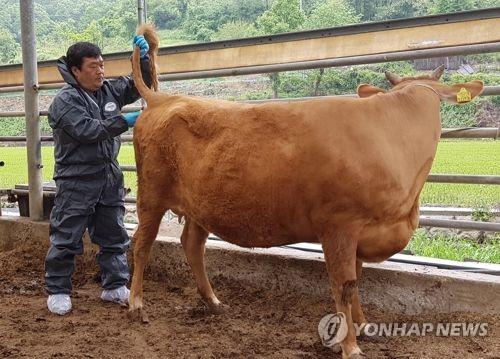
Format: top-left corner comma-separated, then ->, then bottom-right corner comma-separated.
45,36 -> 151,315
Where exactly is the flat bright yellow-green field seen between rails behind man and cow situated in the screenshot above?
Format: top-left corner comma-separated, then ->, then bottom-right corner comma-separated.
0,140 -> 500,208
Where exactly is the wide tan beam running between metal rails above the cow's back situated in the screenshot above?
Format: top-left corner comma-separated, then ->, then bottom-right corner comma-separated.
0,4 -> 500,86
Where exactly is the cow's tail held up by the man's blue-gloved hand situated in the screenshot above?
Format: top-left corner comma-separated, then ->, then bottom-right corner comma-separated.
132,24 -> 160,102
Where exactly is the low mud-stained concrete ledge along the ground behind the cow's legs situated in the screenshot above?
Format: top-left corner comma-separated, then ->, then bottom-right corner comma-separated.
0,217 -> 500,314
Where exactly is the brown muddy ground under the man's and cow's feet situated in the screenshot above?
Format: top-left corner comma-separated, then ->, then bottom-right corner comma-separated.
0,228 -> 500,358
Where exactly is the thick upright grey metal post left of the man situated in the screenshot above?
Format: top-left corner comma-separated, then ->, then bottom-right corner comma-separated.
19,0 -> 43,221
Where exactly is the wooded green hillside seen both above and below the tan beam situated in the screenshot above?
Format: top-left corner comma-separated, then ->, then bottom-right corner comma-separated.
0,0 -> 500,129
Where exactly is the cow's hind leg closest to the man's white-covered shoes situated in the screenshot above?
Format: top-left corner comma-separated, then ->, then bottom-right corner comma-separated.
129,206 -> 165,323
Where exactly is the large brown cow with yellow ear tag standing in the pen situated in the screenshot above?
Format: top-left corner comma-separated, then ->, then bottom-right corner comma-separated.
130,25 -> 483,358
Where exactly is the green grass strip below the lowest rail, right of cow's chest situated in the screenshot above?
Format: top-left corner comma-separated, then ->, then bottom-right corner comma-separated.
406,228 -> 500,264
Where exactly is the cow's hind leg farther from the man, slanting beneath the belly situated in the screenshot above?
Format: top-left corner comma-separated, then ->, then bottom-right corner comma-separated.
181,218 -> 225,314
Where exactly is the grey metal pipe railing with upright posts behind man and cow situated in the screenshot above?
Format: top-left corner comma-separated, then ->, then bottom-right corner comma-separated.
0,4 -> 500,231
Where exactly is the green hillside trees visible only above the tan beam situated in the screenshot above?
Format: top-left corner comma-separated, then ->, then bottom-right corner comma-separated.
0,0 -> 500,64
